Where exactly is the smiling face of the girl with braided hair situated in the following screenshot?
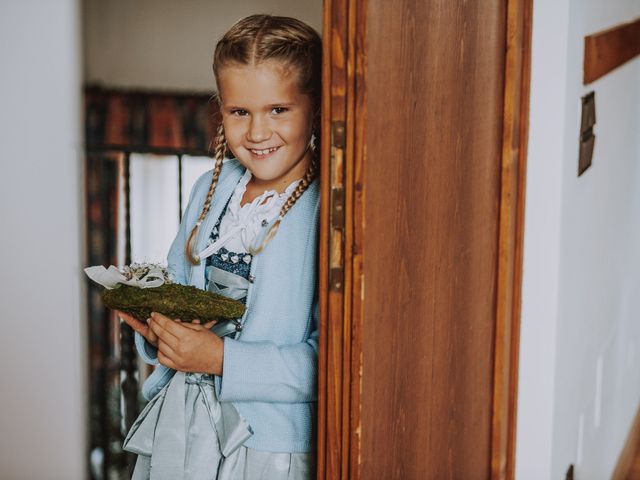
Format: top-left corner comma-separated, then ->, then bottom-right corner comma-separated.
218,60 -> 313,192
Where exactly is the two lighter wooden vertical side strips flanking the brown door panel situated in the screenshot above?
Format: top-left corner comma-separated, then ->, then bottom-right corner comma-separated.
317,0 -> 533,480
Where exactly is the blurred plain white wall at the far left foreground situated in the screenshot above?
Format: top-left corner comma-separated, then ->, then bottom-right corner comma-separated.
0,0 -> 87,480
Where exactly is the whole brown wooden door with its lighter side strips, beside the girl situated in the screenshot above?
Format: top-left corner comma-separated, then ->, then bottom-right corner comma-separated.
318,0 -> 531,480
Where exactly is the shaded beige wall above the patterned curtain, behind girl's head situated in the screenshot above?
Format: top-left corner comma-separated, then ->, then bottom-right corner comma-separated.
84,0 -> 322,92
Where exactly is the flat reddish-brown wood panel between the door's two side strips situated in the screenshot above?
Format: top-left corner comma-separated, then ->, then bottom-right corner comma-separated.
359,0 -> 506,480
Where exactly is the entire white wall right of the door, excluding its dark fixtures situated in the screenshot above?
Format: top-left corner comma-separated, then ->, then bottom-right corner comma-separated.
516,0 -> 640,480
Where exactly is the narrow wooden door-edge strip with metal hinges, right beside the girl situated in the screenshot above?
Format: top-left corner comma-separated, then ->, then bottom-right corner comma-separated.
317,0 -> 356,479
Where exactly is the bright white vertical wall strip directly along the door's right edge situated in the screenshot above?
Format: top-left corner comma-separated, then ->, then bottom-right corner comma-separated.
516,0 -> 569,480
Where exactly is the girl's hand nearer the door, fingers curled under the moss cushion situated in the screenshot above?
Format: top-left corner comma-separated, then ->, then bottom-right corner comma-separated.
149,312 -> 224,375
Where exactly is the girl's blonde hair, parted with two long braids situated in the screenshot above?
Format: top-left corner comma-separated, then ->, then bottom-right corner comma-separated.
185,15 -> 322,265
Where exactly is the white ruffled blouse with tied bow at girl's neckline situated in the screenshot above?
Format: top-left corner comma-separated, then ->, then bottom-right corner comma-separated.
202,169 -> 301,258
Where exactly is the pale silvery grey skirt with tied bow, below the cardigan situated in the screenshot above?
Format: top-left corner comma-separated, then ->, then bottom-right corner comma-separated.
123,372 -> 315,480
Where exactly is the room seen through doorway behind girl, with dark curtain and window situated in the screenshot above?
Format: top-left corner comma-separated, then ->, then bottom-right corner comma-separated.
82,0 -> 323,479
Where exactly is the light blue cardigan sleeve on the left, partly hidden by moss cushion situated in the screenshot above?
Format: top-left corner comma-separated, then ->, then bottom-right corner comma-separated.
135,171 -> 211,365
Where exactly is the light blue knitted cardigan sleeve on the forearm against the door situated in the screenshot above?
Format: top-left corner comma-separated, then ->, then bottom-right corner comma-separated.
215,299 -> 319,403
